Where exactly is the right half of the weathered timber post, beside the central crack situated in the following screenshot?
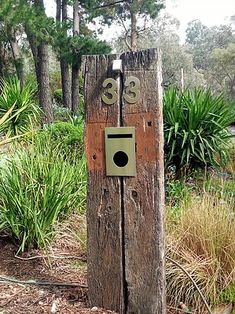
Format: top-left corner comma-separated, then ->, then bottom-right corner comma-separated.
122,50 -> 166,314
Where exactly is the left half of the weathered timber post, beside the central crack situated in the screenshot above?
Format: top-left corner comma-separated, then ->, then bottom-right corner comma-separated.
85,55 -> 124,313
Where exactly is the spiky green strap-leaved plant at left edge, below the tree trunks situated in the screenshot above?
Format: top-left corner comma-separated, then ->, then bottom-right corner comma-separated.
0,78 -> 39,137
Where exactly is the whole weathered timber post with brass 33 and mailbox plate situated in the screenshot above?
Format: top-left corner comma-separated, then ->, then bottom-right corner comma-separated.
85,49 -> 166,314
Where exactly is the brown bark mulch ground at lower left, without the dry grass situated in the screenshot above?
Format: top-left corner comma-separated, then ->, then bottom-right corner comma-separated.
0,241 -> 114,314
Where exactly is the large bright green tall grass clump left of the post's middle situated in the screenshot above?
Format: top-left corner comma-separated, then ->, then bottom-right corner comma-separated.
0,141 -> 86,251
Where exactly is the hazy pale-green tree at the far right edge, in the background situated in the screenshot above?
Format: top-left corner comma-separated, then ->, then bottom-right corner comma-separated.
186,17 -> 235,100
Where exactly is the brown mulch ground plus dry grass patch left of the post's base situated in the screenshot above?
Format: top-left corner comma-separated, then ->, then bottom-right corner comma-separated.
0,216 -> 117,314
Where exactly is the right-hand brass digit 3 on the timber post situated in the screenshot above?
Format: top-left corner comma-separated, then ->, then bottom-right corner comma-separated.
124,76 -> 140,104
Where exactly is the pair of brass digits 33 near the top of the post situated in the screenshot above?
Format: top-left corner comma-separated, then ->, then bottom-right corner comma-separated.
101,76 -> 140,105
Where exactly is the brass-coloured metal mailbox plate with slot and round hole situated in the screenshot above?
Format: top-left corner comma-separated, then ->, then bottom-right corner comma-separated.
105,127 -> 136,177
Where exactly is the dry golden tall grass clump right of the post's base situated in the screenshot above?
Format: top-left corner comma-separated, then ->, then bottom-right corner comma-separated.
166,192 -> 235,313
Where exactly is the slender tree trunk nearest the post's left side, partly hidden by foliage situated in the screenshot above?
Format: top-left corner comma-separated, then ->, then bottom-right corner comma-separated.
72,0 -> 80,114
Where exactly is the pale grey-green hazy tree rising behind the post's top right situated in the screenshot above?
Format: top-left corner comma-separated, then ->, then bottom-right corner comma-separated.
112,14 -> 204,88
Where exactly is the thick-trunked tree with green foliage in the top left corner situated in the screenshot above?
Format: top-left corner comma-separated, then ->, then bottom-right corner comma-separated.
0,0 -> 53,123
